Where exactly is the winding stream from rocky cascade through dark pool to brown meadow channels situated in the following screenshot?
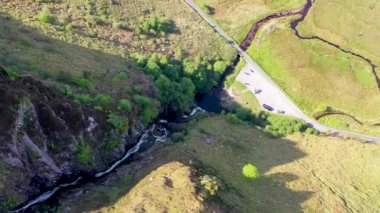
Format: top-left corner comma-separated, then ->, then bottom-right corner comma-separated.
11,0 -> 380,213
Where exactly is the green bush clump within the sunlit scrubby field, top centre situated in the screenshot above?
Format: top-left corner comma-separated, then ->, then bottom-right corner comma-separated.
136,16 -> 174,35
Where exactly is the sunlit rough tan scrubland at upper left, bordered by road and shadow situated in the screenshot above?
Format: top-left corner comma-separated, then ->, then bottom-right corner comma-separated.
0,0 -> 234,59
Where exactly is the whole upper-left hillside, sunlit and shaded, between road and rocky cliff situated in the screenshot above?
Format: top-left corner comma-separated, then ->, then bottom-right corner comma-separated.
0,0 -> 235,130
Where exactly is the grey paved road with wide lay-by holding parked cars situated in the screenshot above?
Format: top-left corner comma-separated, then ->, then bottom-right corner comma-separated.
185,0 -> 380,143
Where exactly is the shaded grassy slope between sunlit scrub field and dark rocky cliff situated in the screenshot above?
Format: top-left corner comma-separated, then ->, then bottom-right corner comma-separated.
0,13 -> 145,85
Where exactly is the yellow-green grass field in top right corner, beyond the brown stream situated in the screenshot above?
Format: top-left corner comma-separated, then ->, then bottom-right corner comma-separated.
299,0 -> 380,65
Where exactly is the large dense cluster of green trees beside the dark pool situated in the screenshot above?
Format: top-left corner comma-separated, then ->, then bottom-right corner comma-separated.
135,53 -> 228,111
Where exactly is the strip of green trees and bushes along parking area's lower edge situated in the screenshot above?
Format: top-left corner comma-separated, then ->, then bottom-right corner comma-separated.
226,107 -> 319,138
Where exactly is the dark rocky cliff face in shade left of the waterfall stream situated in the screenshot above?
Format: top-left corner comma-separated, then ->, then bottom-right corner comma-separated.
0,67 -> 142,212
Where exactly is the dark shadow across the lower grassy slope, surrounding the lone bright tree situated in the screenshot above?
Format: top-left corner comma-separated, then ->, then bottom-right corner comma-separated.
42,113 -> 313,212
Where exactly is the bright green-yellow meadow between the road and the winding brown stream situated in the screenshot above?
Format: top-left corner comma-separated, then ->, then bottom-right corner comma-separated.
248,19 -> 380,135
